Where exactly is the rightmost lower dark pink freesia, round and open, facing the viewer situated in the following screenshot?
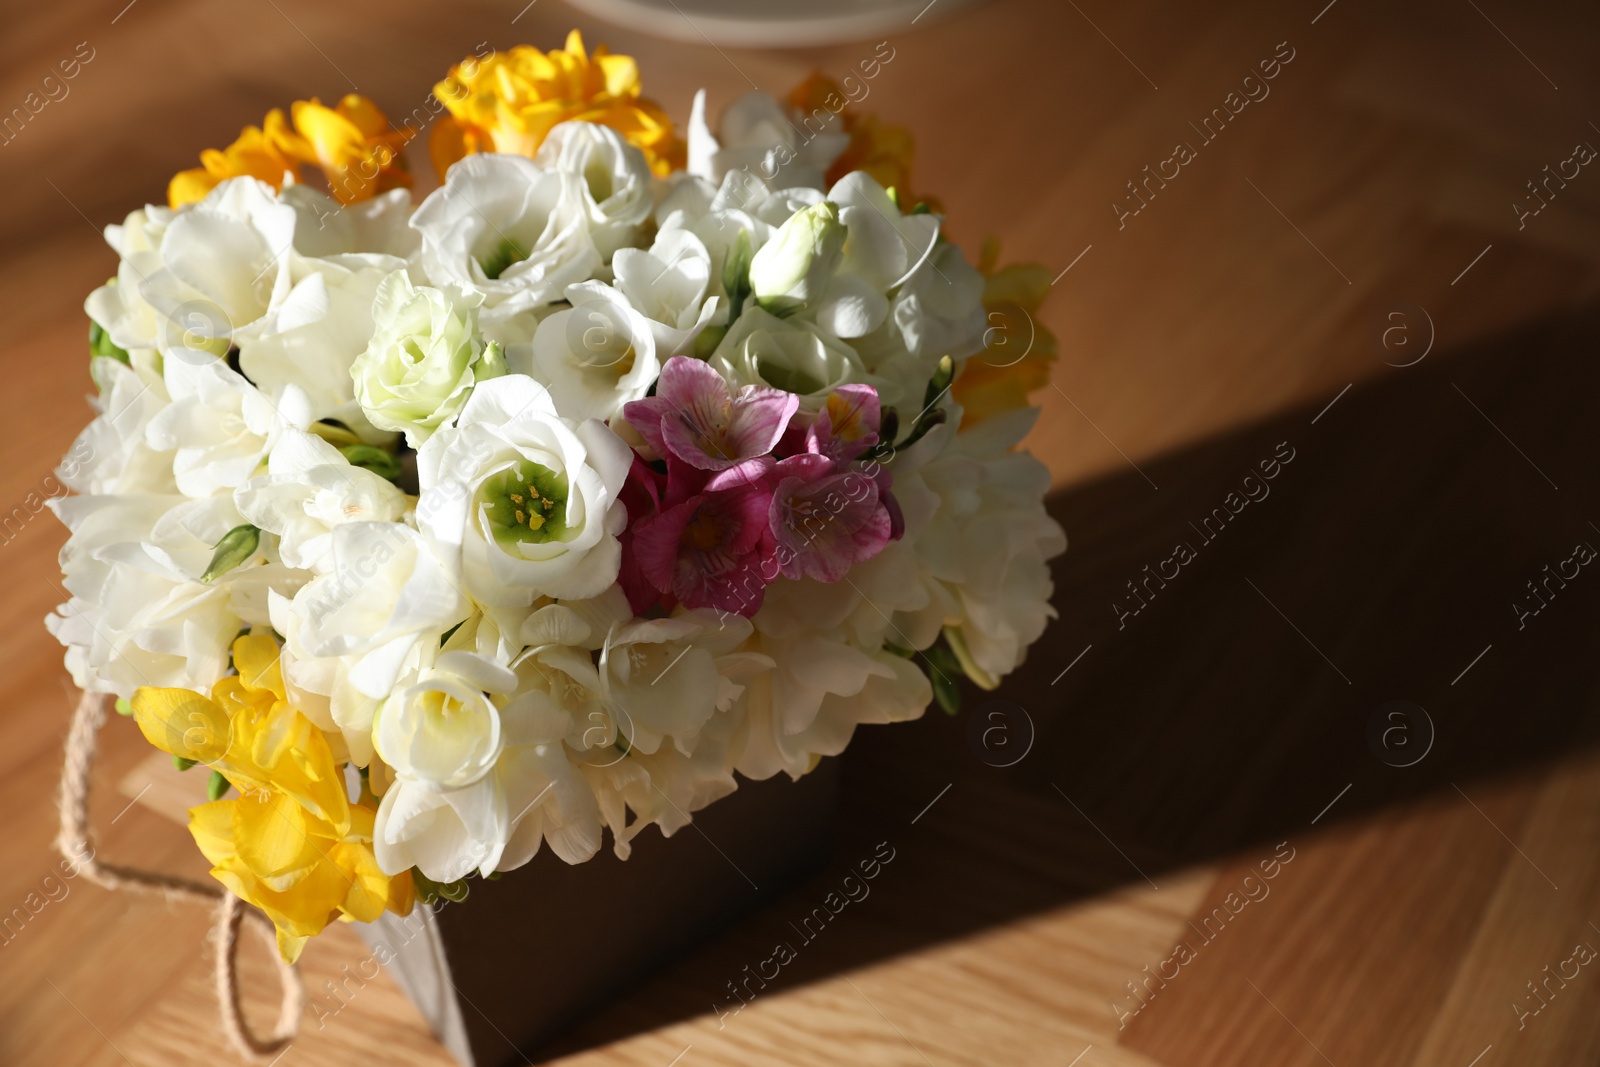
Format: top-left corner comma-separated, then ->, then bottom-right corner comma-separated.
768,453 -> 899,582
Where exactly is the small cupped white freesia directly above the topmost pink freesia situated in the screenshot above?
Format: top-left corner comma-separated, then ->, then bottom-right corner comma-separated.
611,229 -> 720,360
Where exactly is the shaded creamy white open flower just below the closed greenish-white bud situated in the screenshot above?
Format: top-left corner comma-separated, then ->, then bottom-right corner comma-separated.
709,307 -> 877,411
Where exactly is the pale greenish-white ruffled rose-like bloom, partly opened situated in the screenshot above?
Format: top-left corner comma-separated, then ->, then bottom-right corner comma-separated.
350,270 -> 504,448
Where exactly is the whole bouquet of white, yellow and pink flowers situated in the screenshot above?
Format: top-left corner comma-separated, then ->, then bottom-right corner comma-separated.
48,34 -> 1066,961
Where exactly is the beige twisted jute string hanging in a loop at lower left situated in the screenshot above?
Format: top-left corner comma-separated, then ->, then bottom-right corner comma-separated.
56,693 -> 306,1062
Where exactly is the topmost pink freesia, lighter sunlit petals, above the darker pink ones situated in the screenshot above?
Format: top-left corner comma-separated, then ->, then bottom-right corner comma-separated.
622,355 -> 800,482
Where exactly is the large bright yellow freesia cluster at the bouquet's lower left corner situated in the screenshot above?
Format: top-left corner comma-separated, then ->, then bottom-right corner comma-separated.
130,635 -> 414,963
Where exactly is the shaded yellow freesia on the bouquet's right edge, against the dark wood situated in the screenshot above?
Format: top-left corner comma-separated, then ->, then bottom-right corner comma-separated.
950,240 -> 1059,429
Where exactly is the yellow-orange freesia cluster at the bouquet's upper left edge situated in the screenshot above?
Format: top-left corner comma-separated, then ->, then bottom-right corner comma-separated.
166,93 -> 411,208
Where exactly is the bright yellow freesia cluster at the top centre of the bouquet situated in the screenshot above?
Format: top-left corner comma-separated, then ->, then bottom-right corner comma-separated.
429,30 -> 683,181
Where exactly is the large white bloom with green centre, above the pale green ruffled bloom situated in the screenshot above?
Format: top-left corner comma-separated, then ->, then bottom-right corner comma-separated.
411,154 -> 600,317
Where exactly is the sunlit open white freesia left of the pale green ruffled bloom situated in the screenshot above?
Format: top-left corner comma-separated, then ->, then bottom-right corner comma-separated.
144,357 -> 312,496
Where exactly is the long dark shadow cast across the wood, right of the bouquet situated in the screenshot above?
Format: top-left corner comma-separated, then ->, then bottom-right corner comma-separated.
505,302 -> 1600,1062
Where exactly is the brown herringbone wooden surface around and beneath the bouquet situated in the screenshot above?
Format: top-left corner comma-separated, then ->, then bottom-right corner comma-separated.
0,0 -> 1600,1067
